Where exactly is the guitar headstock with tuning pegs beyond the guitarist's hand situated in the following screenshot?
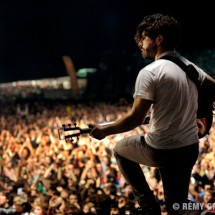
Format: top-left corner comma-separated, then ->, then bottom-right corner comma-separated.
58,123 -> 91,141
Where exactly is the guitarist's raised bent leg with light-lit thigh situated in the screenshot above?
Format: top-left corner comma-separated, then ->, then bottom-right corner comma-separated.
114,136 -> 161,215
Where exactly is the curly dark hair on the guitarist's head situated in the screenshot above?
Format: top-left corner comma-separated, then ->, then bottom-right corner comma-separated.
135,13 -> 182,49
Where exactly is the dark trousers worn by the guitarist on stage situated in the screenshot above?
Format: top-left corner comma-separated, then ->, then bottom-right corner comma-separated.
114,135 -> 199,211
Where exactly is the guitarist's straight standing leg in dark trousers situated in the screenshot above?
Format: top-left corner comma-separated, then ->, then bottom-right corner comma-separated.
159,144 -> 199,215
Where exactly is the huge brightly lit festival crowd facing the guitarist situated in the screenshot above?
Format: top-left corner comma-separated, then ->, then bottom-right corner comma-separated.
0,101 -> 215,215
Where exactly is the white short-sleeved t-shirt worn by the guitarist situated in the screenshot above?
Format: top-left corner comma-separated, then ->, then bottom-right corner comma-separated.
134,53 -> 206,149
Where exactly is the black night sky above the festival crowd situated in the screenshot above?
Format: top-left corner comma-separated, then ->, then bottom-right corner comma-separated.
0,0 -> 215,82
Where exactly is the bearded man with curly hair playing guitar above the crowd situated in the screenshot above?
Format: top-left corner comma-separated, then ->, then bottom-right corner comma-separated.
90,14 -> 214,215
